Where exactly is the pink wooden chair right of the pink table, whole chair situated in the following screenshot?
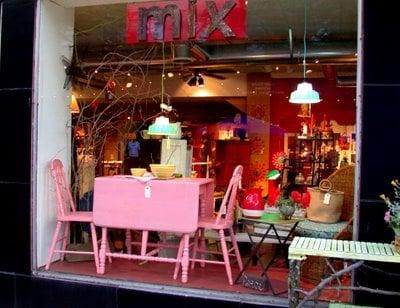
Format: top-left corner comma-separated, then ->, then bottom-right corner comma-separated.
187,165 -> 243,285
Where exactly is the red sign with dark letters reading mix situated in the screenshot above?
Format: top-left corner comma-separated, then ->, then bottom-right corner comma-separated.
126,0 -> 246,44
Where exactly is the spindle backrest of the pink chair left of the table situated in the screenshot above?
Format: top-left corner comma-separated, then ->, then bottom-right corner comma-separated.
50,159 -> 76,217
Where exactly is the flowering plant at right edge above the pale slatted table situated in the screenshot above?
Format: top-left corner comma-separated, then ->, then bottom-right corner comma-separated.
380,180 -> 400,253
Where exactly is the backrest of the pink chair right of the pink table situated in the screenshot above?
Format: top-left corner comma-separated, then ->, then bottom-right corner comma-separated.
215,165 -> 243,224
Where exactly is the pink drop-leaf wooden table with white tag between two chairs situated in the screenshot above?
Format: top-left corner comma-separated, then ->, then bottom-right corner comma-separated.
93,176 -> 214,282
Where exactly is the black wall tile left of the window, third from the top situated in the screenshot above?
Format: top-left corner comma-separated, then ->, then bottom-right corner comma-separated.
0,182 -> 30,274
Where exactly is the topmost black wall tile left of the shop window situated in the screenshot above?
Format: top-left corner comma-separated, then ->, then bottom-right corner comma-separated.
0,0 -> 35,88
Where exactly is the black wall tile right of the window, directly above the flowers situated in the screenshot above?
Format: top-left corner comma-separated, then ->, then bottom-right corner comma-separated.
361,86 -> 400,199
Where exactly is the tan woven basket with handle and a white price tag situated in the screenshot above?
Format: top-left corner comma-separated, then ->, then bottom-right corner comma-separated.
307,179 -> 344,223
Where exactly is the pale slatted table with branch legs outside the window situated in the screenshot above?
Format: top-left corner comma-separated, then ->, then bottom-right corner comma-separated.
288,237 -> 400,308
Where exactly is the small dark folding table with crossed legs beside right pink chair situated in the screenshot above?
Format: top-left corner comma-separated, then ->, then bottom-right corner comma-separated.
235,218 -> 303,295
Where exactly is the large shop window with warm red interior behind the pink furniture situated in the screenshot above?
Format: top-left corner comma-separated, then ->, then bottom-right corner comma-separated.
35,0 -> 357,304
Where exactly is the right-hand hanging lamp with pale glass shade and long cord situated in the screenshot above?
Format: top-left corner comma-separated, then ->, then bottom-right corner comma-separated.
289,0 -> 321,104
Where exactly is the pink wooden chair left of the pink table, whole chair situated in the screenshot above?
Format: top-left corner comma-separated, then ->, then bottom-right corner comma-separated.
45,159 -> 99,270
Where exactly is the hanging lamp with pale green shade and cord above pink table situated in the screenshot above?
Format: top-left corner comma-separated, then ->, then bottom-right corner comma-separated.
148,41 -> 178,136
